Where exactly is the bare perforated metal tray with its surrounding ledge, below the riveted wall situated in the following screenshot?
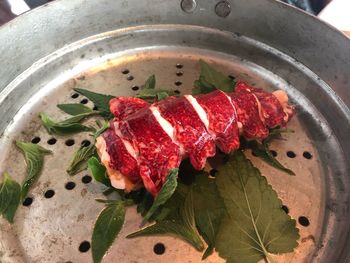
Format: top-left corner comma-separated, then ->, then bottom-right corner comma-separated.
0,0 -> 349,263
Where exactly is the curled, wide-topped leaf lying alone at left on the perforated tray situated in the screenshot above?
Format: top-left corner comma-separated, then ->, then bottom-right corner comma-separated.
16,141 -> 51,200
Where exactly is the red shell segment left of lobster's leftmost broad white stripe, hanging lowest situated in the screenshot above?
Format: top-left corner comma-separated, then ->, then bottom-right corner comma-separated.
119,108 -> 181,195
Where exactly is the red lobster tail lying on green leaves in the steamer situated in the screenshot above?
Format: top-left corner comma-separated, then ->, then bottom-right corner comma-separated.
96,82 -> 294,196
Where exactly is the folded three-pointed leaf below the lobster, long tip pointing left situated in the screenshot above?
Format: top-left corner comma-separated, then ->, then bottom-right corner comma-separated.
127,191 -> 204,251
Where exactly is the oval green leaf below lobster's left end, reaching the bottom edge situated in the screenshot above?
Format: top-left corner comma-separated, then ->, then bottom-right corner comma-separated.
91,201 -> 125,263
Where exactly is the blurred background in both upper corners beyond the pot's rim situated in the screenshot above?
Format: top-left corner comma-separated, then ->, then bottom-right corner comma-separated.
0,0 -> 350,35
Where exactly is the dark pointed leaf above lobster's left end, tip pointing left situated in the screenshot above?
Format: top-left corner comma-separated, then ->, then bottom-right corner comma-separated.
74,88 -> 115,119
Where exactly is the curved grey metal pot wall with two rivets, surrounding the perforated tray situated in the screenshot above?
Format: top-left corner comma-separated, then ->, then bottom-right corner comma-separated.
0,0 -> 350,262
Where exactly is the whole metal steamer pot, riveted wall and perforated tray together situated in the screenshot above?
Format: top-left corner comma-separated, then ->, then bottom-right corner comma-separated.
0,0 -> 350,263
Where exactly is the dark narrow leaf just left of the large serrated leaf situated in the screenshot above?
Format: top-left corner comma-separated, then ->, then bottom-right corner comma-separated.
192,174 -> 226,259
